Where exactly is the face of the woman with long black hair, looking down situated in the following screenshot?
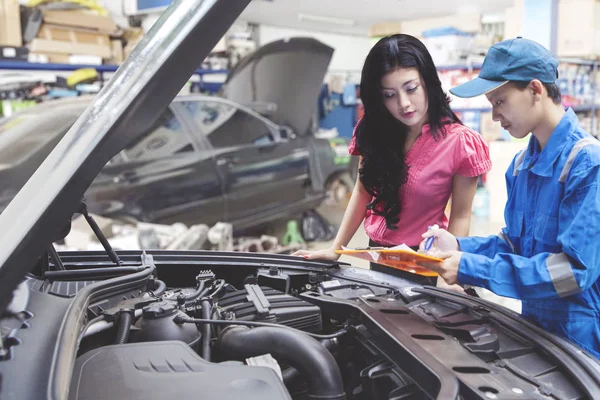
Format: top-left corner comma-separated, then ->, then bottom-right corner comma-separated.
381,68 -> 429,127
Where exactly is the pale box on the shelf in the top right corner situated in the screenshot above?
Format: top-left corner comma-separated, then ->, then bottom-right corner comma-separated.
556,0 -> 600,57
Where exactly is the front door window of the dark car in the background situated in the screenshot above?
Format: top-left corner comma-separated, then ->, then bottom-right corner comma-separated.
180,101 -> 273,148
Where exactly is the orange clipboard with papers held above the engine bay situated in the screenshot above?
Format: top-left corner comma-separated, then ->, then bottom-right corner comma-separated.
335,245 -> 444,277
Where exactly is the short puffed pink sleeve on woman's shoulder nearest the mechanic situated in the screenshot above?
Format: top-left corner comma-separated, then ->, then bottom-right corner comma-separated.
456,129 -> 492,177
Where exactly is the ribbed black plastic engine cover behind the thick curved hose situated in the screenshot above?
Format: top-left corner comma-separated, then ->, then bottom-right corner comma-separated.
218,285 -> 323,333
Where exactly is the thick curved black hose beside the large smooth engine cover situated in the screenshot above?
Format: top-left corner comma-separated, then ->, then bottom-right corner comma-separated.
217,326 -> 346,400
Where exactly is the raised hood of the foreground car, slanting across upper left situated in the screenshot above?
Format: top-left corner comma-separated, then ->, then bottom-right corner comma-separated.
0,0 -> 250,312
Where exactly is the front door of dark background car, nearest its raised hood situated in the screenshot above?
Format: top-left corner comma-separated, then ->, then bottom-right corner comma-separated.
172,98 -> 309,228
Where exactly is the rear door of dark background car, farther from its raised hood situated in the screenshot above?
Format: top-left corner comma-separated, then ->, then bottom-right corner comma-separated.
92,104 -> 225,226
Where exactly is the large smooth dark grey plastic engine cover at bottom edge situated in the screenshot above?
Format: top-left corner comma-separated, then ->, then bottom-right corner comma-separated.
69,341 -> 291,400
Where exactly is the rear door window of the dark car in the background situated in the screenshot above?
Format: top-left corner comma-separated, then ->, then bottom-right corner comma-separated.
116,108 -> 194,164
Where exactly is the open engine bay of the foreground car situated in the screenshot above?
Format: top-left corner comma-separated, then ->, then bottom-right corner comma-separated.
0,252 -> 591,400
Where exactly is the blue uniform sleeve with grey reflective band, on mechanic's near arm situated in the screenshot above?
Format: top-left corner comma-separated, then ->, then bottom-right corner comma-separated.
458,148 -> 600,300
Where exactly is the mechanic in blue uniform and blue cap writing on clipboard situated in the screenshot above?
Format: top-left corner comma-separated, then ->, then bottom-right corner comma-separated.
420,37 -> 600,358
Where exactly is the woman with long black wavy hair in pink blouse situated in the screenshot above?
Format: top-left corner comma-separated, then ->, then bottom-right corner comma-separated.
294,34 -> 491,288
